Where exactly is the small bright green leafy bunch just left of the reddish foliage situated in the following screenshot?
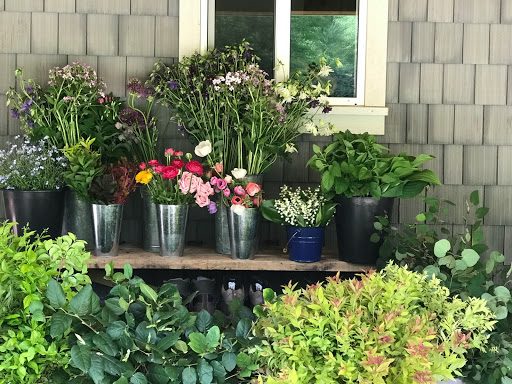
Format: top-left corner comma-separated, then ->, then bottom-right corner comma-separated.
64,139 -> 103,201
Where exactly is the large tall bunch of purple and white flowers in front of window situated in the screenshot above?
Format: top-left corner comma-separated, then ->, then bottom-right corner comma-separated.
150,42 -> 330,174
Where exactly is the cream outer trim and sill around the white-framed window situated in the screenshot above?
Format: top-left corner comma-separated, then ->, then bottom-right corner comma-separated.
178,0 -> 388,134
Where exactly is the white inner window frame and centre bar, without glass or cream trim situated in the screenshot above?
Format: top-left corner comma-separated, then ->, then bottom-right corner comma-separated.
206,0 -> 368,106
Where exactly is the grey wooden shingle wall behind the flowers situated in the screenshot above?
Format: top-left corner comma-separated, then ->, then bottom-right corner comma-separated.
0,0 -> 512,257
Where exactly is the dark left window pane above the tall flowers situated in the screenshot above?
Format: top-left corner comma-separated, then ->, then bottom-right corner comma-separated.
215,0 -> 274,76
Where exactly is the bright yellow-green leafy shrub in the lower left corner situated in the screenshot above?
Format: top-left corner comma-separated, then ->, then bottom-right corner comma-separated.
0,223 -> 90,384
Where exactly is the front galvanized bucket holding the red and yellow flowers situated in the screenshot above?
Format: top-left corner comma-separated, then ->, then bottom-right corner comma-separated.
156,204 -> 188,256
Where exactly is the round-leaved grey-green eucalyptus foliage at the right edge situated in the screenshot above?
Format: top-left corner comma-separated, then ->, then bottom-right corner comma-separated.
376,191 -> 512,384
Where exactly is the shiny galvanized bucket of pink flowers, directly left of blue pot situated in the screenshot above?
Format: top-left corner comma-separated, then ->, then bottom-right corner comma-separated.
228,208 -> 260,259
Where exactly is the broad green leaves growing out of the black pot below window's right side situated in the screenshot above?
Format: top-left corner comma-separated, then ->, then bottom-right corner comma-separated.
308,131 -> 440,198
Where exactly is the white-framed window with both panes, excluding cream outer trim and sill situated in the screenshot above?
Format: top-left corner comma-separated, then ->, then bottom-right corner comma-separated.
208,0 -> 366,105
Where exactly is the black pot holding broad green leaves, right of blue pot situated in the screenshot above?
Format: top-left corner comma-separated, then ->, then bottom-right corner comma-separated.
335,197 -> 395,265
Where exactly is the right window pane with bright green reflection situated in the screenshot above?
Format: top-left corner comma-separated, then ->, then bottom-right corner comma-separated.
290,0 -> 358,97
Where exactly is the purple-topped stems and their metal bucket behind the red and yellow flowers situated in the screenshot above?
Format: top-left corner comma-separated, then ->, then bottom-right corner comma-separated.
118,79 -> 160,253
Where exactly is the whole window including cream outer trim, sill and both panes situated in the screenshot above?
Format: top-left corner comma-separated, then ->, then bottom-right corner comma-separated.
179,0 -> 388,134
